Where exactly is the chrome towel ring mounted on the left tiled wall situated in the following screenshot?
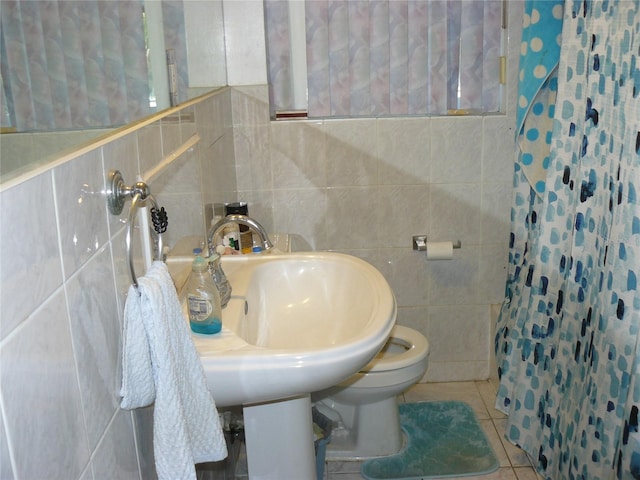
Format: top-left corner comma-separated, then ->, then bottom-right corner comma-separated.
107,170 -> 168,288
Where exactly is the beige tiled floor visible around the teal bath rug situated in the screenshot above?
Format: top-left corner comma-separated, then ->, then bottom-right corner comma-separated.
325,381 -> 538,480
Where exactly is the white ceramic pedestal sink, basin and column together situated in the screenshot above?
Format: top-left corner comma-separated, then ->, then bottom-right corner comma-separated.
167,252 -> 396,480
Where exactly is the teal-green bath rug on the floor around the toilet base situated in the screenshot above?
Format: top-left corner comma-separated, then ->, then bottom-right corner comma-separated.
361,402 -> 499,480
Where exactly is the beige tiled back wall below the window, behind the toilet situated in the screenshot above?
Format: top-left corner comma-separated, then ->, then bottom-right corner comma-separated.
232,87 -> 514,381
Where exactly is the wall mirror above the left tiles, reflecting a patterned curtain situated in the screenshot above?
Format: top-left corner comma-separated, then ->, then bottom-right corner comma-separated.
0,0 -> 227,182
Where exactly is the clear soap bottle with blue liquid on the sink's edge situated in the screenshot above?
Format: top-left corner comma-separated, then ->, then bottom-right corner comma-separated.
187,255 -> 222,334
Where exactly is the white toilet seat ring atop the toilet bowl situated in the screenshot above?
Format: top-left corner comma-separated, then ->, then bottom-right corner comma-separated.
359,325 -> 429,373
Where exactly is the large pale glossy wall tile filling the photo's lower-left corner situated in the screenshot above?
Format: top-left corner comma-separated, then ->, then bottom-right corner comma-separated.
0,289 -> 90,480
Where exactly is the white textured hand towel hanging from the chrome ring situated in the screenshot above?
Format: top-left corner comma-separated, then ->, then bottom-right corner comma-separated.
120,261 -> 227,480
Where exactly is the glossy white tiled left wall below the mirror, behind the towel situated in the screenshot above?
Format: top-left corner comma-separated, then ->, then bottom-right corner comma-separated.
0,89 -> 236,480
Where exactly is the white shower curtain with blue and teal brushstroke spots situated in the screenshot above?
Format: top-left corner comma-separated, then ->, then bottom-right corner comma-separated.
495,0 -> 640,480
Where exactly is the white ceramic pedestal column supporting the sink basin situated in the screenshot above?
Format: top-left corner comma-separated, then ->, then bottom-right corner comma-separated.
243,395 -> 316,480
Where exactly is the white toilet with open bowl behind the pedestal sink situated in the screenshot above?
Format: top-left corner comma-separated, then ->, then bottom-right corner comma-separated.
312,325 -> 429,460
